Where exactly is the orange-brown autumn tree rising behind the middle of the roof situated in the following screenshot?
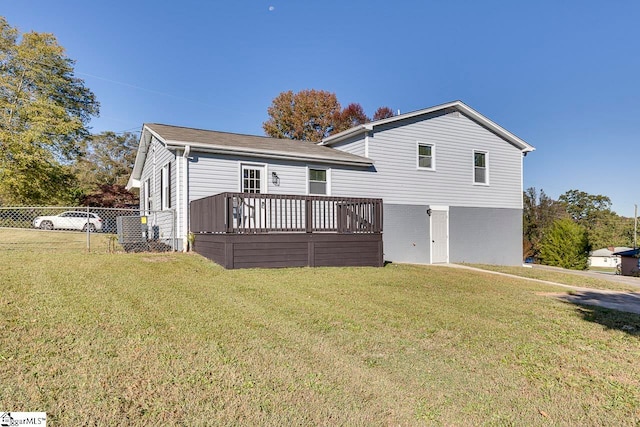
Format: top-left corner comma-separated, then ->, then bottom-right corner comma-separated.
262,89 -> 340,142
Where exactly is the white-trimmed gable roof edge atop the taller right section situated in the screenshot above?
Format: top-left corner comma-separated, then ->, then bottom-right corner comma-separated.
321,101 -> 535,153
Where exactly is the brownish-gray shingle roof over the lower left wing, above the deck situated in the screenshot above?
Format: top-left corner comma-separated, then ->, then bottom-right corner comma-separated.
145,123 -> 373,166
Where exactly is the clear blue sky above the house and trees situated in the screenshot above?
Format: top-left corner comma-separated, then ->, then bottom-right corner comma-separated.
5,0 -> 640,216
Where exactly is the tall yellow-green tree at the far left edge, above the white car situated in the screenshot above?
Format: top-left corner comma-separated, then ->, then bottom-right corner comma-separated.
0,17 -> 99,204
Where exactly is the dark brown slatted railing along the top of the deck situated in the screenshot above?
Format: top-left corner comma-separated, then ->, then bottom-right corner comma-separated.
190,193 -> 382,234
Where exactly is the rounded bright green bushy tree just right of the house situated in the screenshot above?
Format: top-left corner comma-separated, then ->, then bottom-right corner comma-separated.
540,218 -> 591,270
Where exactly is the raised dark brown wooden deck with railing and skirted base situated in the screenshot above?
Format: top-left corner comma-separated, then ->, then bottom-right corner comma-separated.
190,193 -> 384,269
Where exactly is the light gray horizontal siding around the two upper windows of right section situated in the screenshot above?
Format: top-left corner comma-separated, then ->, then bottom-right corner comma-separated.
331,114 -> 522,209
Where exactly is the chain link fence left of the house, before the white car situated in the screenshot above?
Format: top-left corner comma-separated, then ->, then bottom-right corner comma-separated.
0,206 -> 178,252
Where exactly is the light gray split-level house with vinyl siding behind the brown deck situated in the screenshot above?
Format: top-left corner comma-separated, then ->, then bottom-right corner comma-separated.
128,101 -> 534,265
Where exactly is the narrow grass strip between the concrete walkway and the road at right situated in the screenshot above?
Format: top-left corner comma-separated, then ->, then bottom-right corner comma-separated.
469,264 -> 640,292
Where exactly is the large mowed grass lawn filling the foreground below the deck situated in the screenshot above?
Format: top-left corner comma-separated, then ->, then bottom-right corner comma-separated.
0,230 -> 640,425
